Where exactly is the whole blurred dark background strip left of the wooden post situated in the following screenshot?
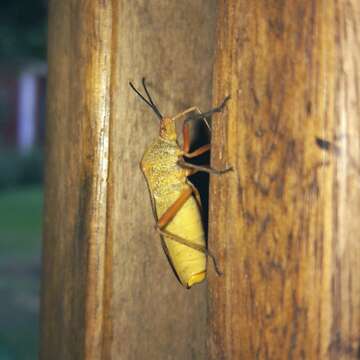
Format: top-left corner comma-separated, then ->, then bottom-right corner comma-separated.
0,0 -> 47,360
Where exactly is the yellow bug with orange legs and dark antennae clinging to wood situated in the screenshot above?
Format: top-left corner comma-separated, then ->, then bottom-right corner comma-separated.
129,78 -> 231,288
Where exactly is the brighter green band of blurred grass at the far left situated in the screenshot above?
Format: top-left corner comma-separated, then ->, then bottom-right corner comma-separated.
0,186 -> 43,255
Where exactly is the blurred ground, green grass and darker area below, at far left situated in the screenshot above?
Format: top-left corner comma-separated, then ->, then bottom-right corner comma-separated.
0,186 -> 43,360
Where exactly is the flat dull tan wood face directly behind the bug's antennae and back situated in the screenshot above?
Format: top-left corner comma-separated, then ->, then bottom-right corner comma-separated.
106,0 -> 215,359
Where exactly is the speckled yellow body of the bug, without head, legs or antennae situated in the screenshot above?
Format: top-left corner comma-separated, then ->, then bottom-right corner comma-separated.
141,136 -> 206,287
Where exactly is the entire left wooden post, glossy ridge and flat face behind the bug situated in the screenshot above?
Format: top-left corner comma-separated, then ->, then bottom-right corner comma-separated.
41,0 -> 215,360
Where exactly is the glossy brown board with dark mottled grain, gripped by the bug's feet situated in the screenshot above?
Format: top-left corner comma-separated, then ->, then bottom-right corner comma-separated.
208,0 -> 360,359
